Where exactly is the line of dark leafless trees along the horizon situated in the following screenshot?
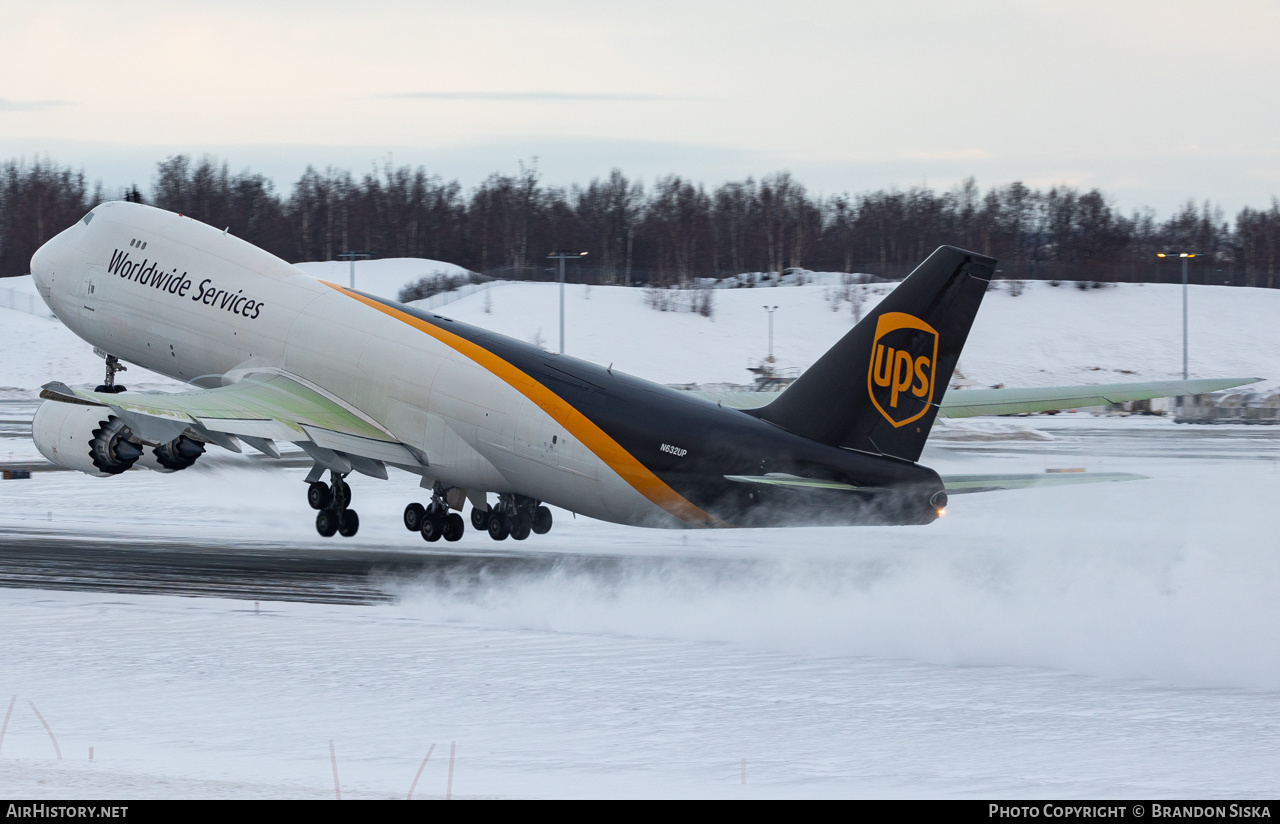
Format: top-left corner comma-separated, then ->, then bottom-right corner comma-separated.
0,155 -> 1280,288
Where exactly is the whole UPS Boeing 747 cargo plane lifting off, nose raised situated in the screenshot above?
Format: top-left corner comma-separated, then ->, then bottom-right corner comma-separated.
31,202 -> 1240,541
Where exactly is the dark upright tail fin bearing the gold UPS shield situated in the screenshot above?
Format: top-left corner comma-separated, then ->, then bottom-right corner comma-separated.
753,246 -> 996,461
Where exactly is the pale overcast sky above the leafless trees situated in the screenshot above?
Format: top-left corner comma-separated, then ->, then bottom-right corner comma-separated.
0,0 -> 1280,215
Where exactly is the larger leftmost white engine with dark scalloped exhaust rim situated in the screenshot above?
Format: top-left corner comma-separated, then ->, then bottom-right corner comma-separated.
31,400 -> 143,477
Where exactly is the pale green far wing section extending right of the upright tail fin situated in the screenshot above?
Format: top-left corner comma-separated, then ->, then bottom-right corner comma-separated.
938,377 -> 1262,417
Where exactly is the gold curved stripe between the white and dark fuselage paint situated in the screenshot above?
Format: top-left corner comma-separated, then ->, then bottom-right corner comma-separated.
320,280 -> 732,527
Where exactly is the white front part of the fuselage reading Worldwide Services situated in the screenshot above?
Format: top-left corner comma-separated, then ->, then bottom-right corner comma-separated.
32,202 -> 684,526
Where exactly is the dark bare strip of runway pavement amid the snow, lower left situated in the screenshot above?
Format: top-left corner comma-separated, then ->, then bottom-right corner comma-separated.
0,528 -> 750,604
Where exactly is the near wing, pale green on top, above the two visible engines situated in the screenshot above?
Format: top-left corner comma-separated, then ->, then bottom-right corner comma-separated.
40,372 -> 426,479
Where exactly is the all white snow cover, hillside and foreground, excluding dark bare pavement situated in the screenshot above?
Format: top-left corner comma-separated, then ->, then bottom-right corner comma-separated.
0,266 -> 1280,798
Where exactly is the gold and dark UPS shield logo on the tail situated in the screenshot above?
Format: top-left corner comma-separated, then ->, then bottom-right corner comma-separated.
867,312 -> 938,427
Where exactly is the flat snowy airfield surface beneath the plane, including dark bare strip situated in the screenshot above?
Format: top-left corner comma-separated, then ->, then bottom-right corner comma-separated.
0,415 -> 1280,798
